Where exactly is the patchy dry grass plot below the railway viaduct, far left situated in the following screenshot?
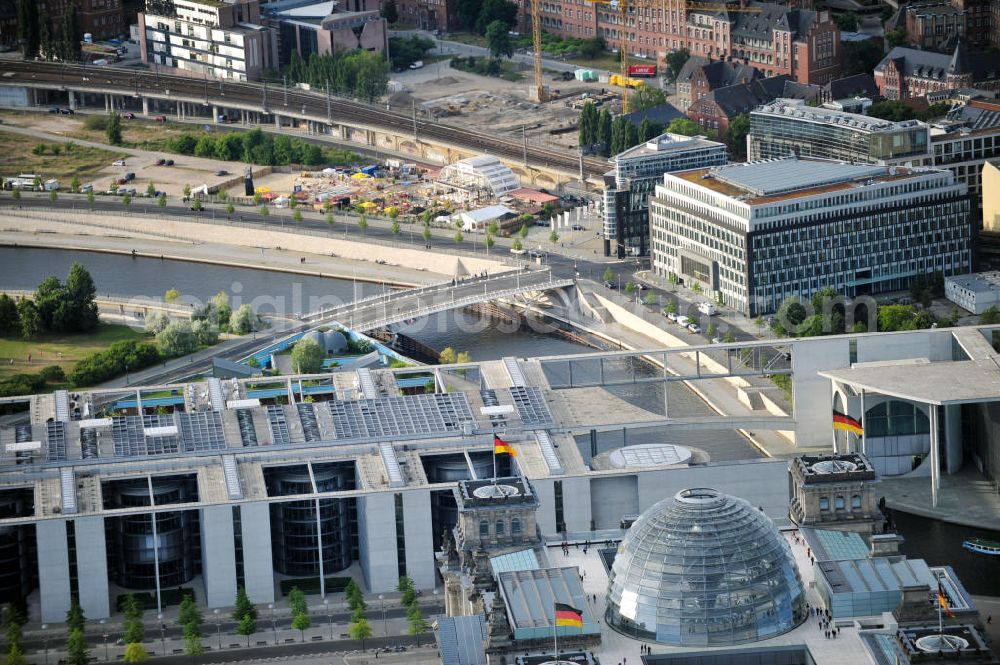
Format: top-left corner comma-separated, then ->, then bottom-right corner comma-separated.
0,132 -> 127,188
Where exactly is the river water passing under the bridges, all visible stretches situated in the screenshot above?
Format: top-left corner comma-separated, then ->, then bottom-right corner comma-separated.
7,247 -> 1000,595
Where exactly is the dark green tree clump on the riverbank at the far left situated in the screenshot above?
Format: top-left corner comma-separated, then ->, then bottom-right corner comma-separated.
0,263 -> 98,339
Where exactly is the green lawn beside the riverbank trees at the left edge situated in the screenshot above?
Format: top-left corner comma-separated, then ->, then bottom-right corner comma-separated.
0,323 -> 149,379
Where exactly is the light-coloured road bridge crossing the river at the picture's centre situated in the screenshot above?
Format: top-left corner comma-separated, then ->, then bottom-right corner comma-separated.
301,270 -> 574,332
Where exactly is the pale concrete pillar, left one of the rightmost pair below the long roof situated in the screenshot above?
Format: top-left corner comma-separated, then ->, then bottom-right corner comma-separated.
358,493 -> 394,593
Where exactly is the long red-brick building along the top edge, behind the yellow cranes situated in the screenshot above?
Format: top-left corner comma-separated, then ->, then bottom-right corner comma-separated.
517,0 -> 842,84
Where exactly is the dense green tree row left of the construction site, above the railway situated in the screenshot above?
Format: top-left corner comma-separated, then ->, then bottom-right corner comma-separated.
283,49 -> 389,102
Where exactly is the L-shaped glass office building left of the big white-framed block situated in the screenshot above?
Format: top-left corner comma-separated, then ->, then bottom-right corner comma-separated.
604,133 -> 728,258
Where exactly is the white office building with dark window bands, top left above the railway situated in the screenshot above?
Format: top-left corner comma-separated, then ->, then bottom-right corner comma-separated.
139,0 -> 275,81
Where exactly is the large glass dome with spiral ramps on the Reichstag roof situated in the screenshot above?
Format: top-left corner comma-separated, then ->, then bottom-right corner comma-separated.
606,488 -> 806,646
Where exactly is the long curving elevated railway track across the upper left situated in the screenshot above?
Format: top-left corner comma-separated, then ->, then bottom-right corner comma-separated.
0,61 -> 609,178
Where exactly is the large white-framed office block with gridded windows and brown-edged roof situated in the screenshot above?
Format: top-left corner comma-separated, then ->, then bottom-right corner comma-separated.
649,158 -> 972,316
